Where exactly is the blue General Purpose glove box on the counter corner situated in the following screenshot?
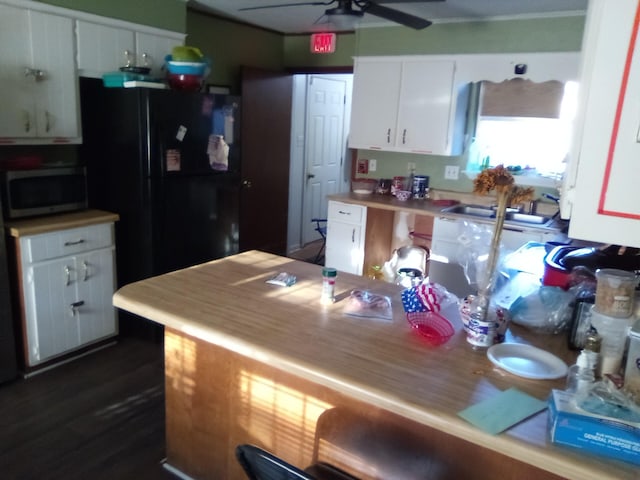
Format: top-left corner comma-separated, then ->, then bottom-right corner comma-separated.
549,390 -> 640,465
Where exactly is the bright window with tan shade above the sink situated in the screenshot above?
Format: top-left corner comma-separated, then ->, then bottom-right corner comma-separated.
468,79 -> 578,185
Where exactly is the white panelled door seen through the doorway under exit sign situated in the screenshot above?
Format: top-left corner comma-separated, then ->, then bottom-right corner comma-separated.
302,75 -> 347,244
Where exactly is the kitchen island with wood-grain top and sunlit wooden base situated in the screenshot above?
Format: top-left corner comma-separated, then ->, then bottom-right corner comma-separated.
114,251 -> 638,480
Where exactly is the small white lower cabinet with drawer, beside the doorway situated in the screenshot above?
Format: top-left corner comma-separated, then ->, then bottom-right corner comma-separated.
325,201 -> 367,275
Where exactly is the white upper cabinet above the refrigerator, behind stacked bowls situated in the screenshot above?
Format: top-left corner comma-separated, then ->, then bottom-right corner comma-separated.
76,20 -> 184,78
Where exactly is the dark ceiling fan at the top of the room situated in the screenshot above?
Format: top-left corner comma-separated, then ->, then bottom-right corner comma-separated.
239,0 -> 445,30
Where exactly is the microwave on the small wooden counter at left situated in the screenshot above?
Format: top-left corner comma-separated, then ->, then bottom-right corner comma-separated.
2,167 -> 88,219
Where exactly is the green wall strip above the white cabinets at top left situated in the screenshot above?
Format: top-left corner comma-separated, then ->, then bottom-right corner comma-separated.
36,0 -> 187,33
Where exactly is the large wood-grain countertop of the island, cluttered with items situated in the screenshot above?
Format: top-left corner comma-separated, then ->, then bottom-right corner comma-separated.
114,251 -> 638,480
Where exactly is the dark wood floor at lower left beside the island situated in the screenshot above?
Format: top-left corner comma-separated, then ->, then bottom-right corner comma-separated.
0,338 -> 176,480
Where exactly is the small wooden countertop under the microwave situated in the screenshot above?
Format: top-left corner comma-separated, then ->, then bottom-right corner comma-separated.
4,210 -> 120,238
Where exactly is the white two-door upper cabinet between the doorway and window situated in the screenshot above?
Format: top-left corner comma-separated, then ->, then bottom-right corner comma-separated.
349,57 -> 466,155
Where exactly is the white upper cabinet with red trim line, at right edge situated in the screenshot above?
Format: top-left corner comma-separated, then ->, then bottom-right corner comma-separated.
562,0 -> 640,247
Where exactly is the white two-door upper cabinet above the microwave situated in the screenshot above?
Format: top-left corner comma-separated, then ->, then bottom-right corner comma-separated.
0,4 -> 80,144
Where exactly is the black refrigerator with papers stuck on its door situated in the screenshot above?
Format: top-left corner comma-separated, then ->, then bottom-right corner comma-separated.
79,78 -> 241,333
